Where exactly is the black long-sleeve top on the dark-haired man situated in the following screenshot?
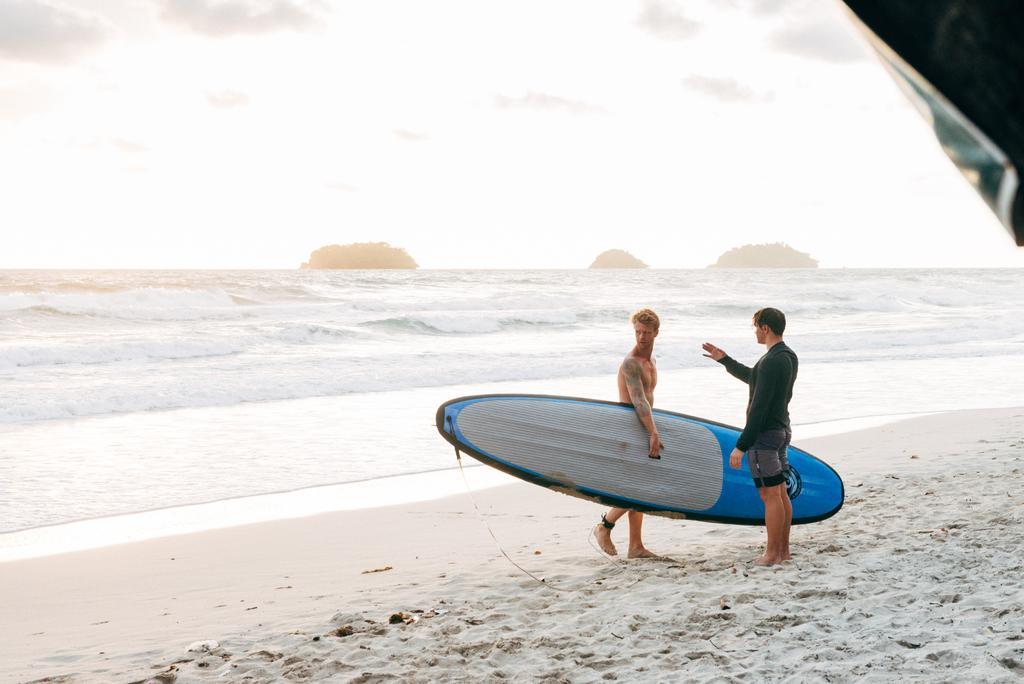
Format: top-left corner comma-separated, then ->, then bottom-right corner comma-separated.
719,342 -> 800,452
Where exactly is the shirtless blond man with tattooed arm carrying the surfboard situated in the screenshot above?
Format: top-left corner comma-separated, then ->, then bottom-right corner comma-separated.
594,309 -> 663,558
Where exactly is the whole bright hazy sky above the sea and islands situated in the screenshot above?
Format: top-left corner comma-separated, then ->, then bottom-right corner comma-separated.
0,0 -> 1024,268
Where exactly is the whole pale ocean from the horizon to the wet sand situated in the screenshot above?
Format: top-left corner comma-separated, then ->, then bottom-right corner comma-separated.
0,269 -> 1024,531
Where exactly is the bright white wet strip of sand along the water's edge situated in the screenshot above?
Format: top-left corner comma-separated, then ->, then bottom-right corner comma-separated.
0,412 -> 942,563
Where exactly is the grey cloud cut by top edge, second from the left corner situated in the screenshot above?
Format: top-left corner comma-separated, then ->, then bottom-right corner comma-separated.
163,0 -> 326,37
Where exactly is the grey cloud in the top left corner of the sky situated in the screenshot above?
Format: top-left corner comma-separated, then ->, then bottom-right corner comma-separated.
0,0 -> 113,63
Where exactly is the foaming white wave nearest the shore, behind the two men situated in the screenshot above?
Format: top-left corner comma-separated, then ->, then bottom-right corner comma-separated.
8,345 -> 1022,424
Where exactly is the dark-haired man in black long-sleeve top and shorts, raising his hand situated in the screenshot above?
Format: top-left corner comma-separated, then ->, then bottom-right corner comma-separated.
703,308 -> 799,565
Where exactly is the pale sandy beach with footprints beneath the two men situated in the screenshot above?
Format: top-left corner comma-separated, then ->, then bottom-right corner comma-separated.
0,409 -> 1024,682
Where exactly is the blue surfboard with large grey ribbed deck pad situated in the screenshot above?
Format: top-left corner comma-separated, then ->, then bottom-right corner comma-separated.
435,394 -> 844,525
